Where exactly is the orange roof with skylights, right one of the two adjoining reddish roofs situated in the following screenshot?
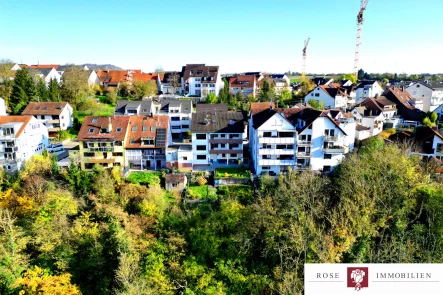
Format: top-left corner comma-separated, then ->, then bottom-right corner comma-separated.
125,116 -> 173,148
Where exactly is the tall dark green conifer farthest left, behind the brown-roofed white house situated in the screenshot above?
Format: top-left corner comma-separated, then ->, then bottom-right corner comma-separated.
9,68 -> 35,114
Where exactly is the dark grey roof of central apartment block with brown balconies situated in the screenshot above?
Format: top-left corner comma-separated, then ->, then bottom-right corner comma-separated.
191,112 -> 246,133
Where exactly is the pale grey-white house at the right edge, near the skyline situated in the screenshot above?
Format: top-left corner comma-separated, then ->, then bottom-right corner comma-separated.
406,81 -> 443,112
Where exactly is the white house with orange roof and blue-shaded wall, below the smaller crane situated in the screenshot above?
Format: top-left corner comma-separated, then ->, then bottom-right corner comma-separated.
305,83 -> 350,109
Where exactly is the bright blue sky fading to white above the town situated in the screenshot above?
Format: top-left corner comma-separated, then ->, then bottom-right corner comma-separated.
0,0 -> 443,74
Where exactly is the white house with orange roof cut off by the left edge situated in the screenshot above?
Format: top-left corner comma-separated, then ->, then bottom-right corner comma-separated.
0,116 -> 49,173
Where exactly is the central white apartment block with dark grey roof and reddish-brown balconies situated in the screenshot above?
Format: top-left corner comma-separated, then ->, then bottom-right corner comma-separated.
191,112 -> 247,167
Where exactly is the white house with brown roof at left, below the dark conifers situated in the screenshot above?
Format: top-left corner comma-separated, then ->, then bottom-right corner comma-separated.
22,102 -> 73,134
